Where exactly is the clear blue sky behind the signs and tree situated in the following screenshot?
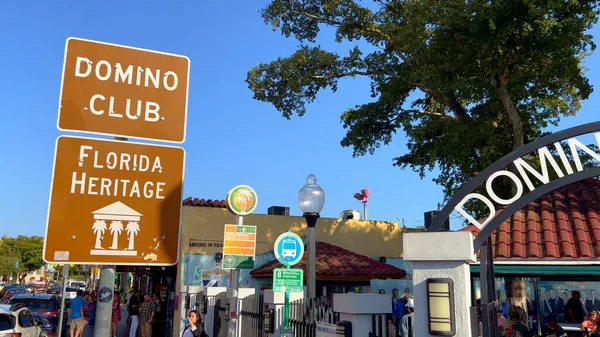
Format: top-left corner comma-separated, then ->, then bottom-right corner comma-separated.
0,0 -> 600,236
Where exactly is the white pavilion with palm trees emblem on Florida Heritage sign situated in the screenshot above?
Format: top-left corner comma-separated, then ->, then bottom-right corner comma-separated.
90,201 -> 142,256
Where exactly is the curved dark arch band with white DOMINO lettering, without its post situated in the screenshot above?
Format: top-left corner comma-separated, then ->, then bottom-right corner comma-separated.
428,122 -> 600,250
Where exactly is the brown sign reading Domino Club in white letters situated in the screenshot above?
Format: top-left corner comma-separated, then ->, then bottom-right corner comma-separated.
57,38 -> 190,143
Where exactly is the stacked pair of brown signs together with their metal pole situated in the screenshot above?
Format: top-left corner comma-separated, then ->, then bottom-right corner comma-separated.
42,38 -> 190,337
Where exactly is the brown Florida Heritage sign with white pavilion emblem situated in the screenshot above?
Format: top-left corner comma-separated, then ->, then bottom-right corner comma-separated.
44,136 -> 185,265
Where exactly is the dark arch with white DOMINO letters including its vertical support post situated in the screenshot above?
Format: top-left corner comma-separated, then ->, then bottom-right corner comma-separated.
428,122 -> 600,337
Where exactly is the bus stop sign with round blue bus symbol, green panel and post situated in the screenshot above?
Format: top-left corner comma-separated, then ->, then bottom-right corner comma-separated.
273,231 -> 304,337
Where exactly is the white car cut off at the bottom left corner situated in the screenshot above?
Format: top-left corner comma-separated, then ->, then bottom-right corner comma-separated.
0,305 -> 42,337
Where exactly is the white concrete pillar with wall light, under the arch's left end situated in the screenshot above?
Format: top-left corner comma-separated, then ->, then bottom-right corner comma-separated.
403,232 -> 476,337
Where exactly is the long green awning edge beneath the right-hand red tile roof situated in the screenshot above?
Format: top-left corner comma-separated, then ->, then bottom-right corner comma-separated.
471,264 -> 600,279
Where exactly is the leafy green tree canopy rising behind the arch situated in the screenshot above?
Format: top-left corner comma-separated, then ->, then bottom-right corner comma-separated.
246,0 -> 598,205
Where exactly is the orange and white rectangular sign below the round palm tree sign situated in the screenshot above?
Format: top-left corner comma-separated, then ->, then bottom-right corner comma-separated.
222,225 -> 256,269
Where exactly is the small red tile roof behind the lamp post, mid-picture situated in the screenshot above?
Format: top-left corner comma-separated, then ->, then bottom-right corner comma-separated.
250,242 -> 406,281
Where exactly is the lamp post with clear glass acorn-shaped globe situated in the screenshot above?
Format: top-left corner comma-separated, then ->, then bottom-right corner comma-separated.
298,174 -> 325,299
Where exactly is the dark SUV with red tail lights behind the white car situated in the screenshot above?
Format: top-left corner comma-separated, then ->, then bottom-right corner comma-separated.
9,294 -> 68,336
